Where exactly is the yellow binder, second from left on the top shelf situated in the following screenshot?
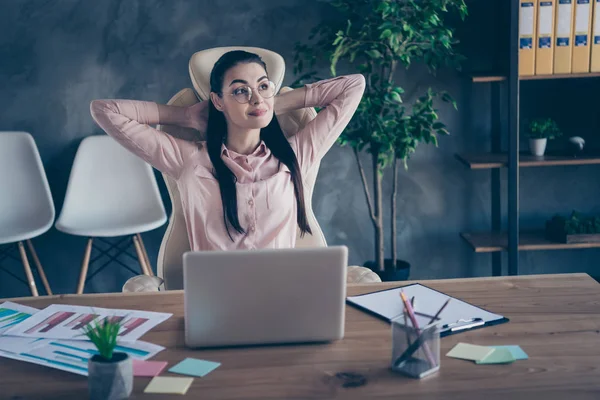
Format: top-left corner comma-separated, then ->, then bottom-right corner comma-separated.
535,0 -> 555,75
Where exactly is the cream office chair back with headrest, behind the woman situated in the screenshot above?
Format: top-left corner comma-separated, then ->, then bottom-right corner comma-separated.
157,46 -> 327,290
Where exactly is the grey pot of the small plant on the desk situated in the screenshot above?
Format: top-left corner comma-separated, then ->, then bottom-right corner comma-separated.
88,353 -> 133,400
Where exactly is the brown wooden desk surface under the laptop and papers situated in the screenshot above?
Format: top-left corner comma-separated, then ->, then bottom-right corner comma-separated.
0,274 -> 600,400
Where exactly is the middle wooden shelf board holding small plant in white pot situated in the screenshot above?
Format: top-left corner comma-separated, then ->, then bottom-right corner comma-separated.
456,153 -> 600,169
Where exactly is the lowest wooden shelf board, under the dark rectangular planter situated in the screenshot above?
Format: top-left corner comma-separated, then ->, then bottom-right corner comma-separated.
460,231 -> 600,253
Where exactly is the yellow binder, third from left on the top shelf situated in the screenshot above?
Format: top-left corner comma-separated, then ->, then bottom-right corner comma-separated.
554,0 -> 575,74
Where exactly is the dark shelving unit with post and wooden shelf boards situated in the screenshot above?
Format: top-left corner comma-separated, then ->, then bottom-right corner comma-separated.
456,0 -> 600,275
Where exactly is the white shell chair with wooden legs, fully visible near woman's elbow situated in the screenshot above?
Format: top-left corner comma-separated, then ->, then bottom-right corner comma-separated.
56,135 -> 167,294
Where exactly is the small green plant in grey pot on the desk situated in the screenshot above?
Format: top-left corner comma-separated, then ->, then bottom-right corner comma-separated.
84,317 -> 133,400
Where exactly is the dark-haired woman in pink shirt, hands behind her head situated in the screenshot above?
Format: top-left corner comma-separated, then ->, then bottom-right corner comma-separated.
90,51 -> 365,251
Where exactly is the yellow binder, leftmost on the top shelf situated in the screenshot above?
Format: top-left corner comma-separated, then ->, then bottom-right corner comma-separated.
519,0 -> 537,76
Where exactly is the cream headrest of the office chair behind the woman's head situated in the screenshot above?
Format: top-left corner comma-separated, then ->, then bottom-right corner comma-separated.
189,46 -> 285,100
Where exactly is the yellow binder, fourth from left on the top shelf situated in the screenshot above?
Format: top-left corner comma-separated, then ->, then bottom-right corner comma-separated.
572,0 -> 592,73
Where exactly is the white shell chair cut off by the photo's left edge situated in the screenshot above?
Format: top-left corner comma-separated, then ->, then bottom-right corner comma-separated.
0,132 -> 55,296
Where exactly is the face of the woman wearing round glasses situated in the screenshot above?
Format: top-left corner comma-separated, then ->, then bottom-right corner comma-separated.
210,63 -> 275,129
